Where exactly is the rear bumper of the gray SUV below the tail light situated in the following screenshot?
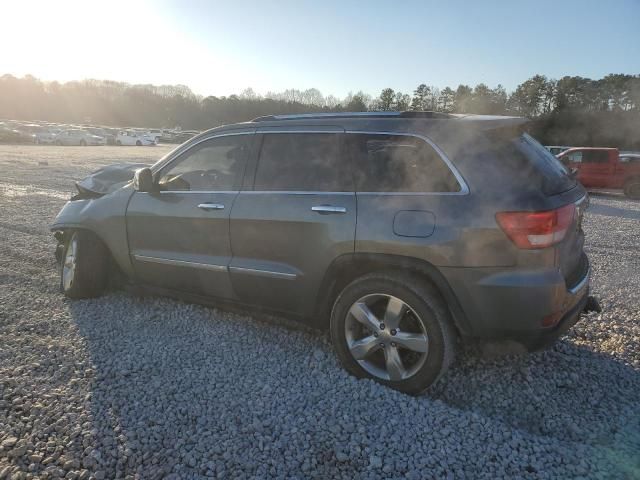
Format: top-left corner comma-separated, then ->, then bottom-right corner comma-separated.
441,261 -> 590,349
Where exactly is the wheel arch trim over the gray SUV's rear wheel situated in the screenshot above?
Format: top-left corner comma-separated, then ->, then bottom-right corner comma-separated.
314,253 -> 471,336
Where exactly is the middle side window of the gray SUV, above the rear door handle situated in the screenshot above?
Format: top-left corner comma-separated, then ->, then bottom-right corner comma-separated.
254,133 -> 353,192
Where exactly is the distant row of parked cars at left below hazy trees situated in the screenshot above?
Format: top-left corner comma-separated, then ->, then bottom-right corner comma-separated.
0,120 -> 200,146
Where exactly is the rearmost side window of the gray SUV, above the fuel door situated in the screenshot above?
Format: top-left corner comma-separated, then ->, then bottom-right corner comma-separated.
347,134 -> 460,192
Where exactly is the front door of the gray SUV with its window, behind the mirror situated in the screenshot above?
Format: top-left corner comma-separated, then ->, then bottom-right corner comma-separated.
127,134 -> 253,298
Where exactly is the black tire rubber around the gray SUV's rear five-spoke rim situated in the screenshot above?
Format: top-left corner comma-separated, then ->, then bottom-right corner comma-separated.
331,275 -> 453,395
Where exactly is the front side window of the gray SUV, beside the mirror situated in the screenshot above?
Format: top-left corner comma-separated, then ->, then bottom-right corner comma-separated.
158,135 -> 252,191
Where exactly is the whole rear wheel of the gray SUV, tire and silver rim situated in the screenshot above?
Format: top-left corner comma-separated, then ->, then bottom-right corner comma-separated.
331,273 -> 456,395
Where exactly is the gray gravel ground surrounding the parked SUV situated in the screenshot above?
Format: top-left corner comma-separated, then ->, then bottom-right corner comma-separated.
0,146 -> 640,479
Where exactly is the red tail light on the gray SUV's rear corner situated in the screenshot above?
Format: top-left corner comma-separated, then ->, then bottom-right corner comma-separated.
496,203 -> 576,249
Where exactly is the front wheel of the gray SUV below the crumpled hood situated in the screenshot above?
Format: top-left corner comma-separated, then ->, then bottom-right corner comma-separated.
60,230 -> 109,298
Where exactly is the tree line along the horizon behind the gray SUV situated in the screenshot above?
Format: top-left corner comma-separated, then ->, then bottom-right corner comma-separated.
0,74 -> 640,149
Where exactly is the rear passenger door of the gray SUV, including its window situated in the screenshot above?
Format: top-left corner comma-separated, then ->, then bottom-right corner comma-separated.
229,127 -> 356,315
